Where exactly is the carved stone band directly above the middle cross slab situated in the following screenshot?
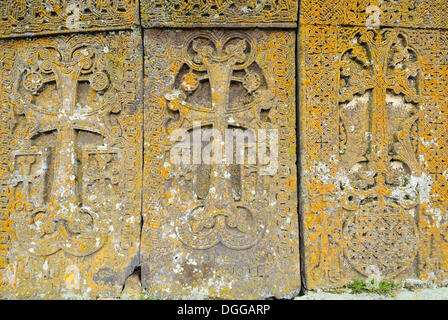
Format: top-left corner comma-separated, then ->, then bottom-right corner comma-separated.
140,0 -> 298,28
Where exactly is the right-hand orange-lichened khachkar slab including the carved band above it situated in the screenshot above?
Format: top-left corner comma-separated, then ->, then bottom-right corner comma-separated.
299,0 -> 448,289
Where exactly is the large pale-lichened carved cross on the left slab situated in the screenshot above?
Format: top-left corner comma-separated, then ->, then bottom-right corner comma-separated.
13,44 -> 114,256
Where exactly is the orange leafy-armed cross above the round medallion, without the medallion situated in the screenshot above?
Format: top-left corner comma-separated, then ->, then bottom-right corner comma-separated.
340,30 -> 418,174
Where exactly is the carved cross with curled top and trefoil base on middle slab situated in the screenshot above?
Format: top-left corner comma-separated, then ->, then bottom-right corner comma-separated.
168,33 -> 265,250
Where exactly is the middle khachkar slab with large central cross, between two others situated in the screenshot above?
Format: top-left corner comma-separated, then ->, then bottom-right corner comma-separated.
141,29 -> 300,299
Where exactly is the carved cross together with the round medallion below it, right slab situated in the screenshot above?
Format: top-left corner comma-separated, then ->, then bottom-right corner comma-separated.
340,30 -> 419,277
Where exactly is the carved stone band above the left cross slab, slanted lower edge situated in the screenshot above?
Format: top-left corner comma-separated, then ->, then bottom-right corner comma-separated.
0,0 -> 138,38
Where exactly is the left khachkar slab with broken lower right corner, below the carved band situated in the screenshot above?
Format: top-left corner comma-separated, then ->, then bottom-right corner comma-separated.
0,32 -> 142,298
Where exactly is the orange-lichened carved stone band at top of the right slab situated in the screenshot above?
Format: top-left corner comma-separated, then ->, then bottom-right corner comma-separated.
300,0 -> 448,28
